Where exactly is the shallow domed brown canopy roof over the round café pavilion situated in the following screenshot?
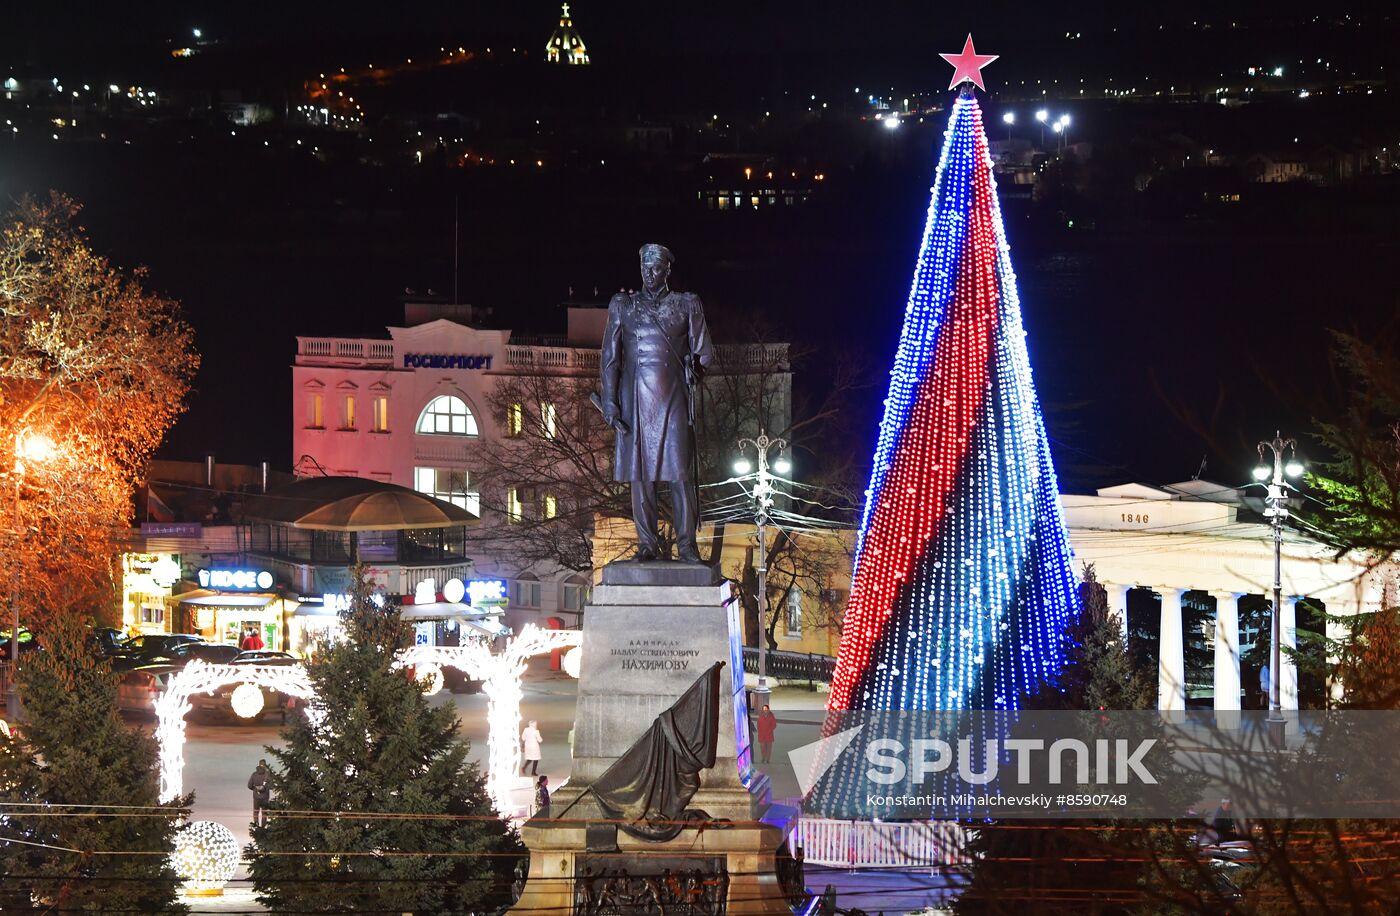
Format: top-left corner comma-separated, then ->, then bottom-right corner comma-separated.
244,478 -> 480,531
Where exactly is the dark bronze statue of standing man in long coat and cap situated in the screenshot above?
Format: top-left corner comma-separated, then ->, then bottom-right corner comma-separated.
599,245 -> 714,563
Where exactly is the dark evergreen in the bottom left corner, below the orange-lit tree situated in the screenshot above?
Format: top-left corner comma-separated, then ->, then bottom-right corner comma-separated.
0,618 -> 189,913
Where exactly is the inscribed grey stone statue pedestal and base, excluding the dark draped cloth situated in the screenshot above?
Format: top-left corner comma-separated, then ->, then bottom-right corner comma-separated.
512,577 -> 795,916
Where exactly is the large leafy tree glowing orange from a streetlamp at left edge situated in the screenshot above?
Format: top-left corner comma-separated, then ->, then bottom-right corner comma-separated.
0,193 -> 199,629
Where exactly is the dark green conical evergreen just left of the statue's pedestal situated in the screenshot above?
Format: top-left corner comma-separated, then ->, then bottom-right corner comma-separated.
248,567 -> 521,913
